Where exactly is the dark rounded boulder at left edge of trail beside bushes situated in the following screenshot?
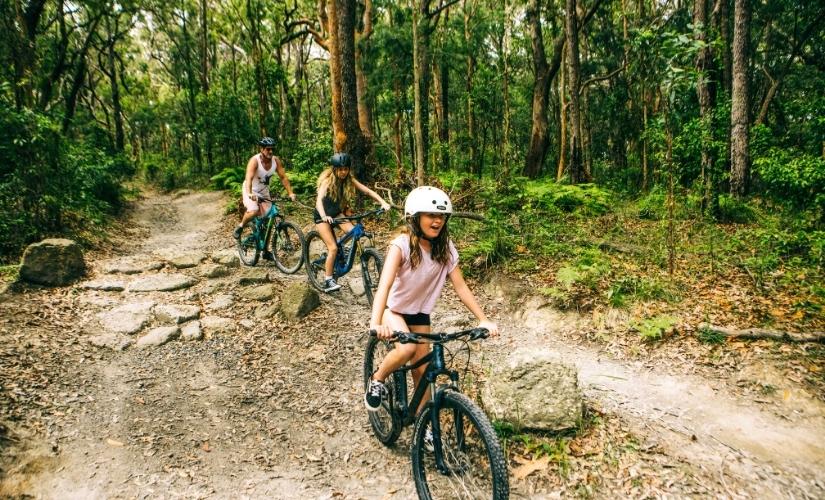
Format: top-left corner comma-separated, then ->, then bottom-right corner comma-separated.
20,238 -> 86,286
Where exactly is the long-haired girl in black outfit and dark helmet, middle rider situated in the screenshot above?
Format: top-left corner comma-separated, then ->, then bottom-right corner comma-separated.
314,153 -> 390,292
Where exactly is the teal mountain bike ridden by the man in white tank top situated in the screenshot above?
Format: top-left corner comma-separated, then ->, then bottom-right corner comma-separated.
237,198 -> 304,274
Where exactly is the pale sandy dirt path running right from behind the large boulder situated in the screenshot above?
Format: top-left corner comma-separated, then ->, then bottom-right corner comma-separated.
502,300 -> 825,498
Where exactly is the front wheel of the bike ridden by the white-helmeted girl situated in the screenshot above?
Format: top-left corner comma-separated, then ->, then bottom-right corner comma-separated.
410,389 -> 510,500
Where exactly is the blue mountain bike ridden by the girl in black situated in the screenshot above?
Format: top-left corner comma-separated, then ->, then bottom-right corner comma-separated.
306,208 -> 384,305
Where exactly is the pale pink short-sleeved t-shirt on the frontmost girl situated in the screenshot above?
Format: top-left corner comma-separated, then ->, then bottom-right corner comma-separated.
387,234 -> 458,314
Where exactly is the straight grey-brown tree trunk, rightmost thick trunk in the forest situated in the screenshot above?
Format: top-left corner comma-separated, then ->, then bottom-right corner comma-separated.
730,0 -> 750,198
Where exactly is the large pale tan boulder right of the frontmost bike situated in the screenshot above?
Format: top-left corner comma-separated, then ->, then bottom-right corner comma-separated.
483,349 -> 583,431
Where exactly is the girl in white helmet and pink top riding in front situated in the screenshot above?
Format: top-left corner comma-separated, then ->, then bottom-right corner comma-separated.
364,186 -> 498,411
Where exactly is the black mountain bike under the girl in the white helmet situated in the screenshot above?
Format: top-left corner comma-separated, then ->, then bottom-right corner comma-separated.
364,328 -> 510,500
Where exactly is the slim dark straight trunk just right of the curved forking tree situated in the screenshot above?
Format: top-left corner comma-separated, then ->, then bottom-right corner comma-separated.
564,0 -> 587,184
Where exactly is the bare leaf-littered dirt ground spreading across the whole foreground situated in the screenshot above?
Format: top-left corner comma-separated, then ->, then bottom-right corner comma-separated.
0,192 -> 825,499
